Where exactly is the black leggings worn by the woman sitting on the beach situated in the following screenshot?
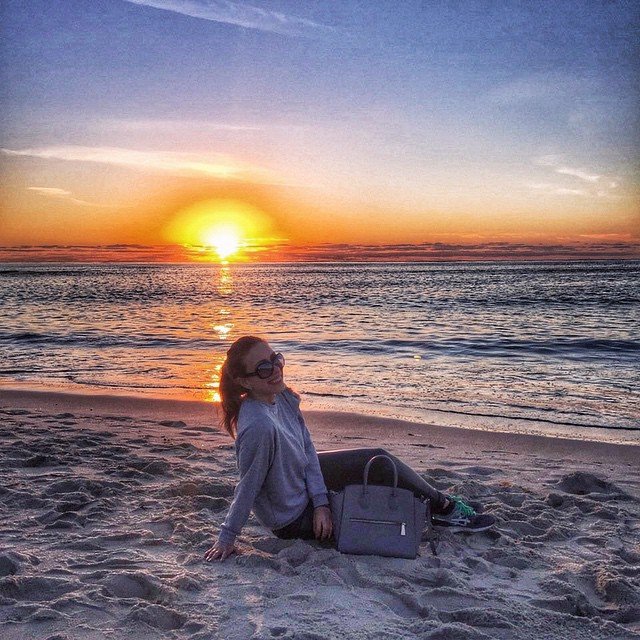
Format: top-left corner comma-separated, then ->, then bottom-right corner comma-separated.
274,448 -> 447,539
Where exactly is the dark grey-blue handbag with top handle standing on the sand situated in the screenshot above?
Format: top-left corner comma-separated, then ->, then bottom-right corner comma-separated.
329,455 -> 427,558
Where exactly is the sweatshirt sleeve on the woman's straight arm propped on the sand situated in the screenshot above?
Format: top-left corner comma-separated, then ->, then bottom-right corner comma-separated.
218,423 -> 274,544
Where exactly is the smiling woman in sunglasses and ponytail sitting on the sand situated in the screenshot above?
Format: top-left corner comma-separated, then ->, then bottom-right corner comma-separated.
205,336 -> 495,560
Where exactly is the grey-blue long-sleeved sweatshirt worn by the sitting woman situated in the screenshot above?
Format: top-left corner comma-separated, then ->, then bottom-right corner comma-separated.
218,389 -> 329,544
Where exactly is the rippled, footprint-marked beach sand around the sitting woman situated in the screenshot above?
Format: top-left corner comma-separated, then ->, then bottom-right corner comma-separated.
0,390 -> 640,640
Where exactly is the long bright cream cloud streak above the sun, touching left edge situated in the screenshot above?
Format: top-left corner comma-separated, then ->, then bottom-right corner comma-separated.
2,146 -> 279,184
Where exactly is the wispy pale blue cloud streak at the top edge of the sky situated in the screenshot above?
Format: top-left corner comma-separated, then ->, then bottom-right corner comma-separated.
125,0 -> 334,37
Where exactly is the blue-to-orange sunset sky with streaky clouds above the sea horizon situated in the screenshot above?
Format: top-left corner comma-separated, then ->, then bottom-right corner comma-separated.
0,0 -> 640,260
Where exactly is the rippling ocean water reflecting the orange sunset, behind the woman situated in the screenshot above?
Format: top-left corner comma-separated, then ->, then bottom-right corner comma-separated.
0,261 -> 640,442
